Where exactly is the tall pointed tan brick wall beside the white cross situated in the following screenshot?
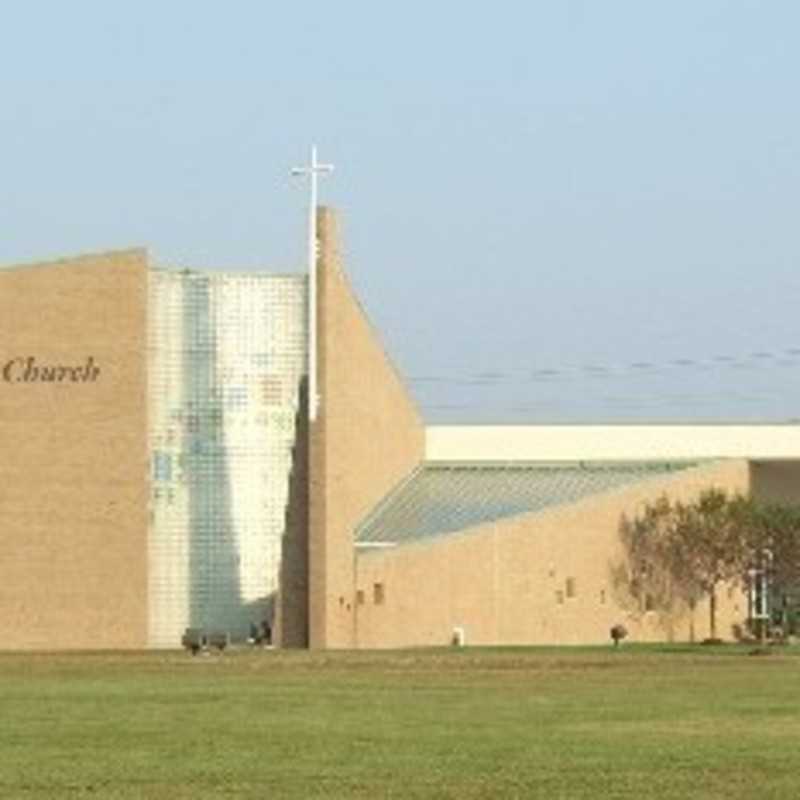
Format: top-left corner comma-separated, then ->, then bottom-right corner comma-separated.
309,208 -> 425,647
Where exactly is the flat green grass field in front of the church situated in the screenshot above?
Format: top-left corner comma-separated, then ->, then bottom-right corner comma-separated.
0,646 -> 800,800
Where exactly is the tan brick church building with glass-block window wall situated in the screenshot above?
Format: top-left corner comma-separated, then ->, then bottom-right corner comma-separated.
0,209 -> 800,649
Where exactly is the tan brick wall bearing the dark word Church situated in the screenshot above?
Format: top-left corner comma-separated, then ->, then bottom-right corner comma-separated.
0,251 -> 147,649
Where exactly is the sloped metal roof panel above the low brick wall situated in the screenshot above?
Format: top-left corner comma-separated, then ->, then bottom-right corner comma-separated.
355,462 -> 694,545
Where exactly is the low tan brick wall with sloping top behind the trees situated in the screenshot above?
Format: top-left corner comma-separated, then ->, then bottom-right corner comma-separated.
356,460 -> 749,648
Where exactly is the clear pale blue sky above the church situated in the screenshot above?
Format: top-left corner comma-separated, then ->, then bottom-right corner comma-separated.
0,0 -> 800,423
